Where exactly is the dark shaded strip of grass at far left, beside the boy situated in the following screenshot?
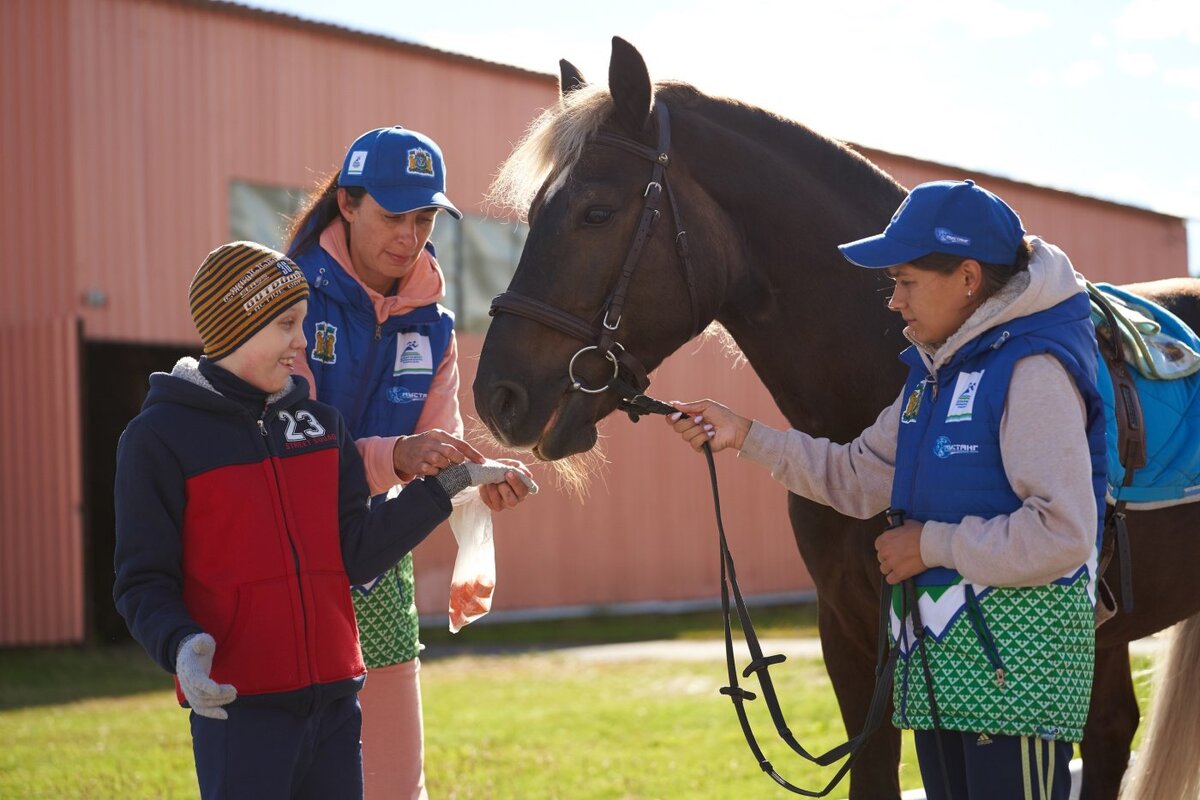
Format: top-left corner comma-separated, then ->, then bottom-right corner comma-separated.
0,644 -> 174,711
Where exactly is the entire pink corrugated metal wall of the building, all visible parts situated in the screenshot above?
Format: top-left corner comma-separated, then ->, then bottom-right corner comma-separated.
0,0 -> 1186,644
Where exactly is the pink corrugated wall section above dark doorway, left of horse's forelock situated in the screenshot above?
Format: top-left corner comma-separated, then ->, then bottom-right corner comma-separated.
67,0 -> 556,343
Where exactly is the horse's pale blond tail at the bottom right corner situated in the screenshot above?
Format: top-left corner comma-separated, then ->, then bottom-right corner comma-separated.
1121,614 -> 1200,800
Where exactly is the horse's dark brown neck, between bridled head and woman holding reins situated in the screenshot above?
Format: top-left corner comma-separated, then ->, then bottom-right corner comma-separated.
681,99 -> 905,440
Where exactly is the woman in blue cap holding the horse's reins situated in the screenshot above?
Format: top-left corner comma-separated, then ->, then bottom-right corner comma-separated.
668,181 -> 1105,800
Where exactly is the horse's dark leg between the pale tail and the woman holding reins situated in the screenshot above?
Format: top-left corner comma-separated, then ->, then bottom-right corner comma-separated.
1080,645 -> 1138,800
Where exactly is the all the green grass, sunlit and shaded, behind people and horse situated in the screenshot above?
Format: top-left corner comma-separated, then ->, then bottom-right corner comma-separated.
0,609 -> 1148,800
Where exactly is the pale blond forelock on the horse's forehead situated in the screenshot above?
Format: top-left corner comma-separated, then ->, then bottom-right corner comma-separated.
487,85 -> 613,217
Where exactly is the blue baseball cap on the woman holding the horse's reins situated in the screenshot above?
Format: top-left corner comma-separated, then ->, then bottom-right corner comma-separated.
838,181 -> 1025,270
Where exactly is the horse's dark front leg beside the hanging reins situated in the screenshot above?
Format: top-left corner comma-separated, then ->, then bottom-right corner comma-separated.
788,495 -> 900,800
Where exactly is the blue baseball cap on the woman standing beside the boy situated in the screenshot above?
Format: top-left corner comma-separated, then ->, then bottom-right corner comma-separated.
337,125 -> 462,219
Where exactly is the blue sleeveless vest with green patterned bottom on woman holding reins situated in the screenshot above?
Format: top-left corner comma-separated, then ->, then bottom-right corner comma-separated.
892,293 -> 1106,741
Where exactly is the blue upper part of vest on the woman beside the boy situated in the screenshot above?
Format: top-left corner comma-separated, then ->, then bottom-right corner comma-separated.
295,245 -> 454,439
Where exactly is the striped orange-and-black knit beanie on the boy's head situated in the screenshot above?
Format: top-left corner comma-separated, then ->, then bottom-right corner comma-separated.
187,241 -> 308,361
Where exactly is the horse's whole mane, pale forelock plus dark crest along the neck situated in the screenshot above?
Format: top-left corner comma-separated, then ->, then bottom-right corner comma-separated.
487,80 -> 899,218
